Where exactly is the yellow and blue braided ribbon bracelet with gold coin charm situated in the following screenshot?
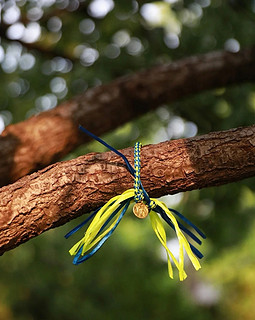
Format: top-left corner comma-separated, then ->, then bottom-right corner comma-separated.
65,126 -> 205,281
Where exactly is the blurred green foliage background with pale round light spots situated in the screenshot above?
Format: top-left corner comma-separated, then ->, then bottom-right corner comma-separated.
0,0 -> 255,320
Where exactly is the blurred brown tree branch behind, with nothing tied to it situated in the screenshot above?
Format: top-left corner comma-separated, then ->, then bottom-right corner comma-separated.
0,49 -> 255,186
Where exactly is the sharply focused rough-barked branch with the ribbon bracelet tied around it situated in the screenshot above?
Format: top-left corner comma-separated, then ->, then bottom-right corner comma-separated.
0,126 -> 255,254
